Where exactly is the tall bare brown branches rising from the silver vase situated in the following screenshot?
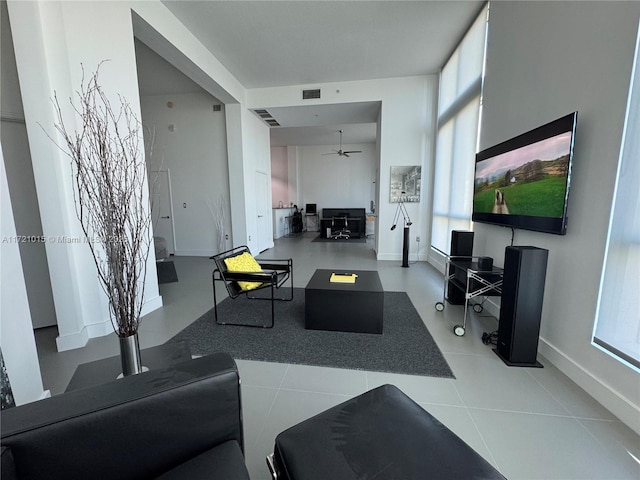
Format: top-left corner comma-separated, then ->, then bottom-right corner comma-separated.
53,62 -> 152,337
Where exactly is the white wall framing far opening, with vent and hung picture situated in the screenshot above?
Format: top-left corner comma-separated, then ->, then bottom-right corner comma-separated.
247,75 -> 438,260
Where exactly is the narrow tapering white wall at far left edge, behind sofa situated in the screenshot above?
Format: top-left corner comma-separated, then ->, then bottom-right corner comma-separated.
0,149 -> 47,405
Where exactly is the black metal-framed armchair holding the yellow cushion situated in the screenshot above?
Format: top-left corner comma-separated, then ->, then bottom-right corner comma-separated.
211,245 -> 293,328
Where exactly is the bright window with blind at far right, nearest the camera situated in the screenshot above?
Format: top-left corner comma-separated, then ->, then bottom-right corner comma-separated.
593,19 -> 640,370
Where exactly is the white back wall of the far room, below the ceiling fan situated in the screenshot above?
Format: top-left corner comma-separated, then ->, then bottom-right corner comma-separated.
297,144 -> 378,214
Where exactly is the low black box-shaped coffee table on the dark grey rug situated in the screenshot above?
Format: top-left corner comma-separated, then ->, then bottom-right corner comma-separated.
304,269 -> 384,333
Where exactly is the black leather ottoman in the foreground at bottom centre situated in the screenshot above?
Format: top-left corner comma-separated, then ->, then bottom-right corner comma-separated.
267,385 -> 504,480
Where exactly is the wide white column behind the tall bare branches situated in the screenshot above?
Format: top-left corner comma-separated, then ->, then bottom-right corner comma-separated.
8,1 -> 161,350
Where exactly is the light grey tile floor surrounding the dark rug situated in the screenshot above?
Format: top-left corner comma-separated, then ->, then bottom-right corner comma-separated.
36,233 -> 640,480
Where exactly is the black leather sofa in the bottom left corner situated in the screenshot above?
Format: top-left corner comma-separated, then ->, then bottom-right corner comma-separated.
0,353 -> 249,480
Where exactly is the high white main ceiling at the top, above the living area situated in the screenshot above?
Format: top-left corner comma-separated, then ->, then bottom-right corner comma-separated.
163,0 -> 483,88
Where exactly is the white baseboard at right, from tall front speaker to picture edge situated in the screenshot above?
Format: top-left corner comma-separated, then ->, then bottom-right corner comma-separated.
538,338 -> 640,435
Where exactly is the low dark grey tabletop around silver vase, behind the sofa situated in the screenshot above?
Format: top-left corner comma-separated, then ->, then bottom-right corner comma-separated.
65,342 -> 191,392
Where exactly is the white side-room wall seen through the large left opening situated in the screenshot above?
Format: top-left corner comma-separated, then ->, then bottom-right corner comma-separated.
140,93 -> 231,256
